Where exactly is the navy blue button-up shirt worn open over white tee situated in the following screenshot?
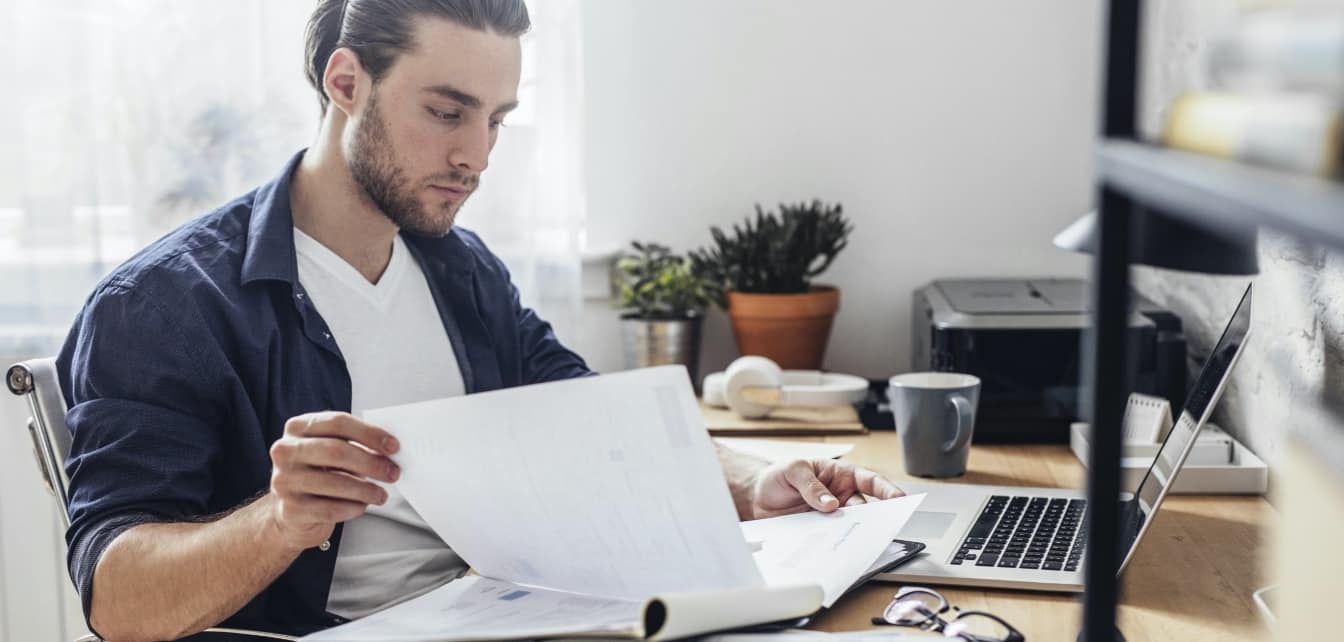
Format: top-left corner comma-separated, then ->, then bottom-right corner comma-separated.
56,153 -> 590,634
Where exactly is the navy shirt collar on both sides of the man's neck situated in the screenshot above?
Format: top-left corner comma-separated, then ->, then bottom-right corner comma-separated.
242,150 -> 476,286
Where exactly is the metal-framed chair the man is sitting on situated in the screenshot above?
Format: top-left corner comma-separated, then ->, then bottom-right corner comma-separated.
5,357 -> 298,642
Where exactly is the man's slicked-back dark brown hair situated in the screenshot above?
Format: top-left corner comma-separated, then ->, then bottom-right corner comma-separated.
304,0 -> 532,114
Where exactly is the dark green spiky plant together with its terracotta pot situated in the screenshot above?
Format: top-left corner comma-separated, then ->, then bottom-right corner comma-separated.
691,200 -> 853,369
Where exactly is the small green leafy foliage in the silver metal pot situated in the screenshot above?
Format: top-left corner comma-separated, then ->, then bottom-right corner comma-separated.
616,240 -> 714,320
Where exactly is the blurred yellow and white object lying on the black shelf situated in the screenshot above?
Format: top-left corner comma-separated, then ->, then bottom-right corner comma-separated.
1161,93 -> 1344,177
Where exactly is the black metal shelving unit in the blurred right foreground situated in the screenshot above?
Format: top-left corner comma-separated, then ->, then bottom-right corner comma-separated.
1079,0 -> 1344,642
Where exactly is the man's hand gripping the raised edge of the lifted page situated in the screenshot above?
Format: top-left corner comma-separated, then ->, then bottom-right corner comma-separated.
270,412 -> 401,551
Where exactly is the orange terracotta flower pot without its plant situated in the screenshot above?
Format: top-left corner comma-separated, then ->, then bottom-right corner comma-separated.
728,285 -> 840,369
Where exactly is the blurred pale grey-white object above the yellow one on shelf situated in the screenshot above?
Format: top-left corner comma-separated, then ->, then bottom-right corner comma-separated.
1208,8 -> 1344,98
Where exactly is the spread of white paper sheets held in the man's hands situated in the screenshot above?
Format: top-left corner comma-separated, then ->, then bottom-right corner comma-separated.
304,367 -> 923,642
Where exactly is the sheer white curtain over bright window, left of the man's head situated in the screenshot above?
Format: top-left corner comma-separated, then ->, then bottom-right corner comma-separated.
0,0 -> 317,353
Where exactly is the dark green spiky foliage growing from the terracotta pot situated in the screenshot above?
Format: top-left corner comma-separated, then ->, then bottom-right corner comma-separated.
689,200 -> 853,306
